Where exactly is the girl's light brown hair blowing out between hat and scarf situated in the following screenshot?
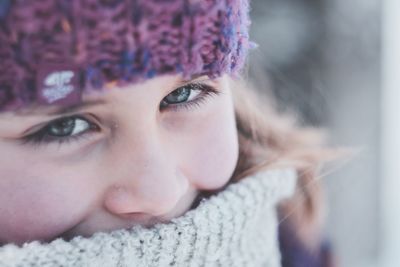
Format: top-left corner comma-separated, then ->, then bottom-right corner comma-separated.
227,76 -> 333,252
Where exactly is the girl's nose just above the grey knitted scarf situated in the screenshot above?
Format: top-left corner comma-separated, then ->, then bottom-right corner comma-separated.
104,124 -> 189,218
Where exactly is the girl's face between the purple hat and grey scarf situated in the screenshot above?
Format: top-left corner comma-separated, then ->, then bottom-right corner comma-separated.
0,76 -> 238,244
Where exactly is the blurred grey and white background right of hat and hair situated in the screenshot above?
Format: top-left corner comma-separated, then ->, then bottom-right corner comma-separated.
250,0 -> 400,267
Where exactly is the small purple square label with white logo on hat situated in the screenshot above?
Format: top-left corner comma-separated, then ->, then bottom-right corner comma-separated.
37,64 -> 81,107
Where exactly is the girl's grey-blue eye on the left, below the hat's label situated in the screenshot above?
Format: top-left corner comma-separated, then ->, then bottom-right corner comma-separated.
23,116 -> 99,147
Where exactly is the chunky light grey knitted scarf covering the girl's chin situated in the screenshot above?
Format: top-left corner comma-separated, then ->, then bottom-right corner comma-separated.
0,170 -> 296,267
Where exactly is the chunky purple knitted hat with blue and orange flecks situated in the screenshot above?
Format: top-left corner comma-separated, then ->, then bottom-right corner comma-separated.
0,0 -> 251,111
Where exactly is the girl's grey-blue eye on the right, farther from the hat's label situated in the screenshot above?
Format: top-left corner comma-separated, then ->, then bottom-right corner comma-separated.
160,83 -> 219,109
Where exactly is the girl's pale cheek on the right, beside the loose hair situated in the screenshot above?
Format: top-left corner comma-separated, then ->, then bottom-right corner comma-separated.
177,96 -> 239,190
